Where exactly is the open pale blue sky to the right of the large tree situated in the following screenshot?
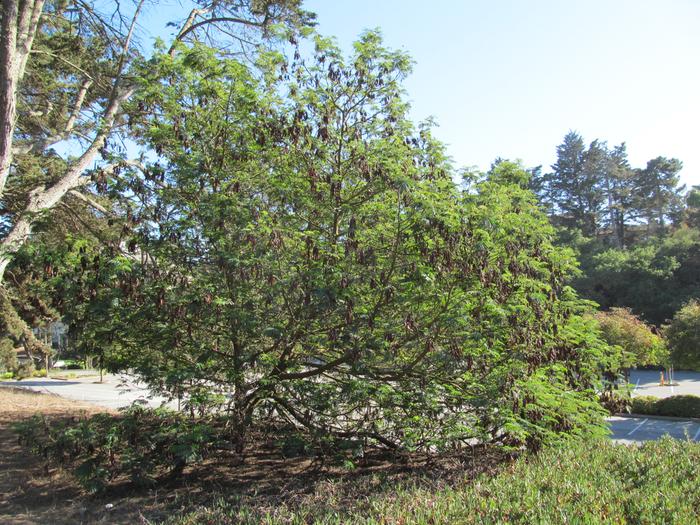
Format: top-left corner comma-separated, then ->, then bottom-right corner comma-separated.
142,0 -> 700,185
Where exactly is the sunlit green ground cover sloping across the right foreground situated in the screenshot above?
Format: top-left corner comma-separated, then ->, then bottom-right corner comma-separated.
165,438 -> 700,525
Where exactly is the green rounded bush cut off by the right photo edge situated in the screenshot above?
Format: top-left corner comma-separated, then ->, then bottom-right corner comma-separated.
664,300 -> 700,370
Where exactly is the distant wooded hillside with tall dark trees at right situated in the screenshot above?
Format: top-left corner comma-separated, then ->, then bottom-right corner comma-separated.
530,131 -> 700,325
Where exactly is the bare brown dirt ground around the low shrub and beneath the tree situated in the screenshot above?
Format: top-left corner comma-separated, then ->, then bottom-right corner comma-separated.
0,388 -> 505,525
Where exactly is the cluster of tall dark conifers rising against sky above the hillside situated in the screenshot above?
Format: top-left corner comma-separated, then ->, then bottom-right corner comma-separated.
530,131 -> 684,248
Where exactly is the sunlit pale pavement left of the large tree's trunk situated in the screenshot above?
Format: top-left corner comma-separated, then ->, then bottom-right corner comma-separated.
0,374 -> 164,409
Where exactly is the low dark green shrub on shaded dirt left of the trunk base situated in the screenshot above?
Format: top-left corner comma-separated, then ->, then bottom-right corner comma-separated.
15,406 -> 220,492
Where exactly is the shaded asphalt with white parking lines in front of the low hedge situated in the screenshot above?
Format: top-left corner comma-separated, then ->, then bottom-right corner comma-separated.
608,416 -> 700,443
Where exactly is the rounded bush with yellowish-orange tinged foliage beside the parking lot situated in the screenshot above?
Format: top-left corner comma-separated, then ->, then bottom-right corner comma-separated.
595,308 -> 668,368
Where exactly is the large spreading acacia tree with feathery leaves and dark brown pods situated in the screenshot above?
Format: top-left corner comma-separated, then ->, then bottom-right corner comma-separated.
66,33 -> 604,448
